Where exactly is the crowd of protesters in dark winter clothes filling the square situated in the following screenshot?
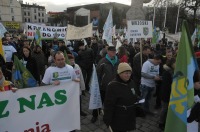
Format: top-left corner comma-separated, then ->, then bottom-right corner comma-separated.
0,29 -> 200,132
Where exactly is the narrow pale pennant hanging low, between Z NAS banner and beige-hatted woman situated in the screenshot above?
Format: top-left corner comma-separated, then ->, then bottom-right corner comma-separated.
89,64 -> 102,110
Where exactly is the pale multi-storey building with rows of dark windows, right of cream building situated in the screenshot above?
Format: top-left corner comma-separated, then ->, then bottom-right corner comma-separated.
19,0 -> 47,23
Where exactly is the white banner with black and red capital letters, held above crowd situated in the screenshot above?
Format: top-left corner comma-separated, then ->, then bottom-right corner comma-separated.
24,23 -> 67,39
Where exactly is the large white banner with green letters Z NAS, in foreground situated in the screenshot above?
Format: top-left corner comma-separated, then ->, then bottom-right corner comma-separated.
0,82 -> 80,132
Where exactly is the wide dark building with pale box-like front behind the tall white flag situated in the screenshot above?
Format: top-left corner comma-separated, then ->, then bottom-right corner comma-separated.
66,2 -> 130,29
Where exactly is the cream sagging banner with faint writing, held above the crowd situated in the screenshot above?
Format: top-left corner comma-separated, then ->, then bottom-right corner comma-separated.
66,23 -> 92,40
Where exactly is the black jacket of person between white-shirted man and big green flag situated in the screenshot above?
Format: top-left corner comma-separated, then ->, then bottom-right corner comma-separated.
160,64 -> 173,103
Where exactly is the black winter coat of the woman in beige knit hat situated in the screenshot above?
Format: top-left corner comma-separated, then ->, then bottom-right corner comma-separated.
103,75 -> 137,131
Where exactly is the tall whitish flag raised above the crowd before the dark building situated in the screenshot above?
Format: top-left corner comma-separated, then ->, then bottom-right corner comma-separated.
102,9 -> 113,46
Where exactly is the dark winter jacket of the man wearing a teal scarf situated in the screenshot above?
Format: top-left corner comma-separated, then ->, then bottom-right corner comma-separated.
96,57 -> 119,91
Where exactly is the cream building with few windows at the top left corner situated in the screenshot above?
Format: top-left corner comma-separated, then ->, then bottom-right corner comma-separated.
0,0 -> 22,22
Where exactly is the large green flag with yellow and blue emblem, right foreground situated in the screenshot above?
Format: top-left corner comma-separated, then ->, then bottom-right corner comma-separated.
165,21 -> 198,132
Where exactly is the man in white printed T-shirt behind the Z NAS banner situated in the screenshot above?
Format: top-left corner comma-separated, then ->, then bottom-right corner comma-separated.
42,51 -> 79,85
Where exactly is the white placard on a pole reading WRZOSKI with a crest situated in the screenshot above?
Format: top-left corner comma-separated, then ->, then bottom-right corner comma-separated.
127,20 -> 152,39
